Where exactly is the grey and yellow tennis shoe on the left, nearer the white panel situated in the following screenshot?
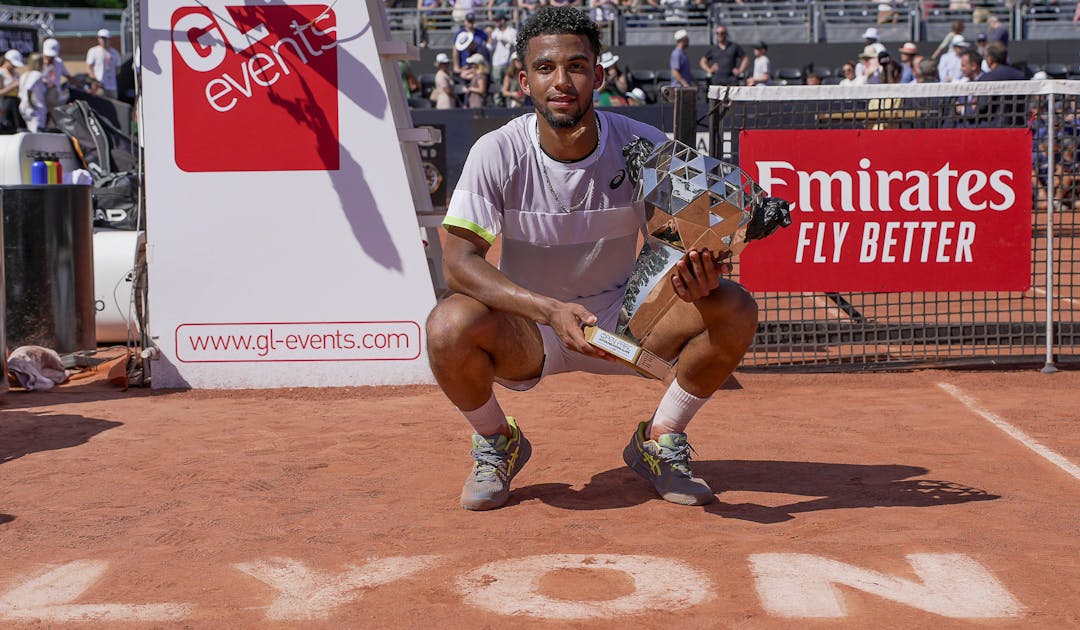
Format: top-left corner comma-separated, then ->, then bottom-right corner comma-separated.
461,416 -> 532,510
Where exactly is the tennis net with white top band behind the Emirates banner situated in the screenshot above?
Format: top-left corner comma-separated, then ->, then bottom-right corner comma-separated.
708,81 -> 1080,371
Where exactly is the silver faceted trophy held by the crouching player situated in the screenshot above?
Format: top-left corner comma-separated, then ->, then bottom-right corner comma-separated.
585,139 -> 792,378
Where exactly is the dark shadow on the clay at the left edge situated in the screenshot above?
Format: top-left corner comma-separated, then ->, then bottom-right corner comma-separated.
0,411 -> 123,464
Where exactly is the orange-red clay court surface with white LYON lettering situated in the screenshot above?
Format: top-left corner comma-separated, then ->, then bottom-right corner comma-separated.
0,371 -> 1080,628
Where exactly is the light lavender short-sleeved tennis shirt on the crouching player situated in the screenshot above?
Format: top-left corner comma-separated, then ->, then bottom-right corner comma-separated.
443,111 -> 667,317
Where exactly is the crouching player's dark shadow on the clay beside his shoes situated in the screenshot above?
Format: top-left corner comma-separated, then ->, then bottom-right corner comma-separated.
510,460 -> 1000,523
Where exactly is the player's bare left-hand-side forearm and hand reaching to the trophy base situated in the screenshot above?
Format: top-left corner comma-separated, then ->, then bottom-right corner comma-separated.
443,226 -> 604,357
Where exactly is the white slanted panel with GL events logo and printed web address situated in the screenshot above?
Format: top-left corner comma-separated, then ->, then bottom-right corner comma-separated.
140,0 -> 435,388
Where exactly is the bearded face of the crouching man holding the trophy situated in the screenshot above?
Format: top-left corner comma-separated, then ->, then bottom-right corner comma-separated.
518,35 -> 604,129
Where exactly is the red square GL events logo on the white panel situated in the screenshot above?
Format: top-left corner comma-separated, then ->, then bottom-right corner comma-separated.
172,4 -> 339,173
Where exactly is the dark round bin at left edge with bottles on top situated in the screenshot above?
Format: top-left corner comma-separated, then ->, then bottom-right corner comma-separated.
0,185 -> 97,354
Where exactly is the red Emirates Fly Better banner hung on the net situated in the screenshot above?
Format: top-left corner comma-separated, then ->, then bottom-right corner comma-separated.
739,129 -> 1031,292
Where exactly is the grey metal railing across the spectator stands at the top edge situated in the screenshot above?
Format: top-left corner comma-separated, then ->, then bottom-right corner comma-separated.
388,0 -> 1080,49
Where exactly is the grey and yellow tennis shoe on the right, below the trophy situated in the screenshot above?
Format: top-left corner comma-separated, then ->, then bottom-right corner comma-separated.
622,421 -> 716,506
